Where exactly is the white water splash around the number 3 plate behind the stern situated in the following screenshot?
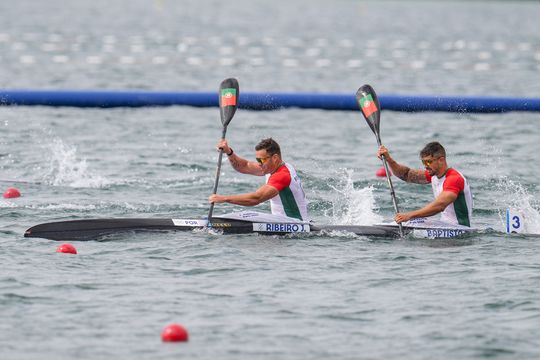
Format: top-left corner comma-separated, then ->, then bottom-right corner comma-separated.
496,177 -> 540,234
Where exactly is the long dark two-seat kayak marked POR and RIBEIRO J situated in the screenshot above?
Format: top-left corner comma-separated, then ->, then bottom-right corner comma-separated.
24,211 -> 478,241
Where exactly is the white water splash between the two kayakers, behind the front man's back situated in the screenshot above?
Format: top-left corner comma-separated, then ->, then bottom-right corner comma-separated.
324,169 -> 383,225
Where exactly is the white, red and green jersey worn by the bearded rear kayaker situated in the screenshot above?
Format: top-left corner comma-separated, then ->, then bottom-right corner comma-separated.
425,168 -> 473,226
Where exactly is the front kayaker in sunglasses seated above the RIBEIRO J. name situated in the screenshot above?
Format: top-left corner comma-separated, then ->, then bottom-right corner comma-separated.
208,138 -> 309,221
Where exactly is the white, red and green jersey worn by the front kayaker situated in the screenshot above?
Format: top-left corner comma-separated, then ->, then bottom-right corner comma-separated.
266,163 -> 309,221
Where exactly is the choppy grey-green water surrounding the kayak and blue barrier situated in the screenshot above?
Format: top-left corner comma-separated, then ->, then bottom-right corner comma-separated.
0,0 -> 540,359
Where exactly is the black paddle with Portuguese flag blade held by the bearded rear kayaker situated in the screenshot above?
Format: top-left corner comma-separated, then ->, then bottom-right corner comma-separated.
356,85 -> 403,236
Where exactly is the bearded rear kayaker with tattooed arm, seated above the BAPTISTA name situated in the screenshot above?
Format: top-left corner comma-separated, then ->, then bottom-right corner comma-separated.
377,142 -> 473,226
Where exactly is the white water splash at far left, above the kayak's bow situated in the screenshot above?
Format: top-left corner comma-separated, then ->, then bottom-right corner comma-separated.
45,139 -> 109,188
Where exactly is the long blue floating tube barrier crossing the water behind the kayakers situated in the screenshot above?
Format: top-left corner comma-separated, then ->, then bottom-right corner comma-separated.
0,90 -> 540,113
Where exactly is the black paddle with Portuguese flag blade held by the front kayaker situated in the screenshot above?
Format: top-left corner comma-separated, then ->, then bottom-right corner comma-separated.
208,78 -> 240,222
